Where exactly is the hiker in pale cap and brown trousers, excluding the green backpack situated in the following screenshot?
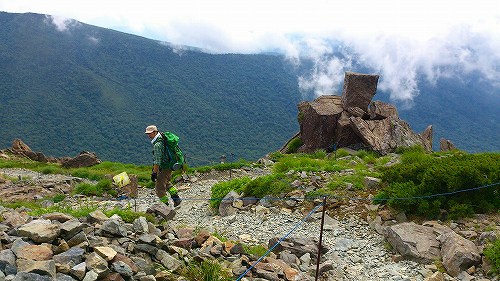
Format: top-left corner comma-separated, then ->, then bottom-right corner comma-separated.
145,125 -> 181,207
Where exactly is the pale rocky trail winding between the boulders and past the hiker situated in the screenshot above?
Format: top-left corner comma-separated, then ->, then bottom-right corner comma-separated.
0,168 -> 496,281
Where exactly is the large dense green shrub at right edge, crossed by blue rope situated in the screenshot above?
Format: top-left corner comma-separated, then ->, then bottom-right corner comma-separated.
376,151 -> 500,218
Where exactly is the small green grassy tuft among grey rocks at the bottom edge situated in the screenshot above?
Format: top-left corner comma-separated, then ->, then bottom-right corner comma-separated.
182,260 -> 233,281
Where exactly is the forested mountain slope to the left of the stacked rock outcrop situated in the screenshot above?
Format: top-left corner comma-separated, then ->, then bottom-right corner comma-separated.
0,14 -> 300,166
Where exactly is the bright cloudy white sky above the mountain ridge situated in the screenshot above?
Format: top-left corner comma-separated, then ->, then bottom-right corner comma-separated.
0,0 -> 500,101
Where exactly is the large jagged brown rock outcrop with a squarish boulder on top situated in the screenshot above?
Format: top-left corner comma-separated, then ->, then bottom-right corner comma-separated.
281,72 -> 440,154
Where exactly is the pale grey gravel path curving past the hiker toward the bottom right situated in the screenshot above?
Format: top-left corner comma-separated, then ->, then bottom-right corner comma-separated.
0,169 -> 429,281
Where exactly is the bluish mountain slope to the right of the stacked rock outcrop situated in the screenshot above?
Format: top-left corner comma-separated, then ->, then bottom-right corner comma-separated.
399,74 -> 500,152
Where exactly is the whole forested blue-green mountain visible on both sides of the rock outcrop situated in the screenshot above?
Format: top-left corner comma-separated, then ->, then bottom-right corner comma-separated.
0,12 -> 500,165
